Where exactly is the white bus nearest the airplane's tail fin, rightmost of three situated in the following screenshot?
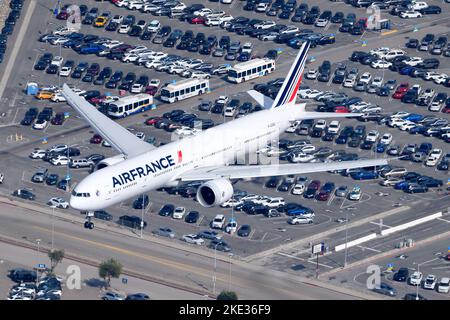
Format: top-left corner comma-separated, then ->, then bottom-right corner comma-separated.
228,58 -> 275,83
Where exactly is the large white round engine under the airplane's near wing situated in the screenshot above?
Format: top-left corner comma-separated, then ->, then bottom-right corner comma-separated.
197,179 -> 233,207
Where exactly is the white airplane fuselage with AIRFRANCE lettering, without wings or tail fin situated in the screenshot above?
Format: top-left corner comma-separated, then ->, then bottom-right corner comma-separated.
70,105 -> 304,211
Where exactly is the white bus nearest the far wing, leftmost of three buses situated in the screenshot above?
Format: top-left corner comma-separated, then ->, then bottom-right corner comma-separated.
108,93 -> 153,118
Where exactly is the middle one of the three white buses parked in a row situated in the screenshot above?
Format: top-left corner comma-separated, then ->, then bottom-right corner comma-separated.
161,79 -> 209,103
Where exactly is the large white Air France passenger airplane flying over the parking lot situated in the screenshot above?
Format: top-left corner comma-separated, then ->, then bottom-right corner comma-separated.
62,42 -> 387,212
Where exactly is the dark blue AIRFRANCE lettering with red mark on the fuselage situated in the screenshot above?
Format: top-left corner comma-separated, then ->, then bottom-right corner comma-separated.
112,151 -> 178,188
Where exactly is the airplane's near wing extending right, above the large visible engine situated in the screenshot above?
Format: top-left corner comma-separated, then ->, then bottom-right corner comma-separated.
178,159 -> 388,181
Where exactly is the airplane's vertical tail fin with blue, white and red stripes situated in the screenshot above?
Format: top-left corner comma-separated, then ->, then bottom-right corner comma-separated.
272,41 -> 310,108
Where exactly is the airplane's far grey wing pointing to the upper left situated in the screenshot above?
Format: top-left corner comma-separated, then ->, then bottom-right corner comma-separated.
62,84 -> 155,157
